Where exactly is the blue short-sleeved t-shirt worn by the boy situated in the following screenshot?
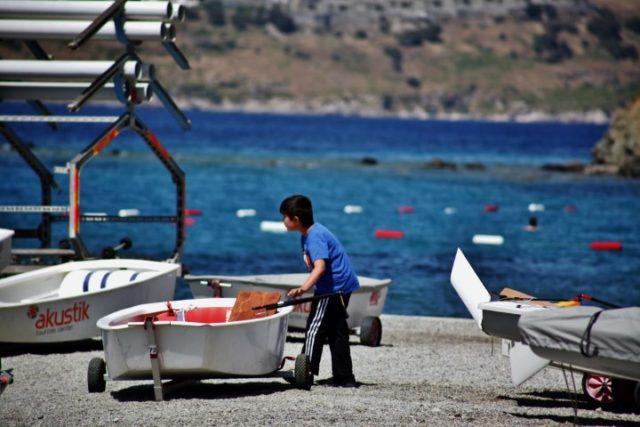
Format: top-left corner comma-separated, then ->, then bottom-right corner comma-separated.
300,222 -> 360,294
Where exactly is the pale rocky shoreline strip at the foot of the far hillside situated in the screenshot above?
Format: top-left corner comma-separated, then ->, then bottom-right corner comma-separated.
172,98 -> 611,125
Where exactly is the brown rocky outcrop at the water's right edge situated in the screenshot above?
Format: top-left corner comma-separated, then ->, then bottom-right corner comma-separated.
591,97 -> 640,177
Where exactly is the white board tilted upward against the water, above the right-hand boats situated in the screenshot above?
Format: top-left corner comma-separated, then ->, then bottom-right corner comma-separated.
451,248 -> 491,328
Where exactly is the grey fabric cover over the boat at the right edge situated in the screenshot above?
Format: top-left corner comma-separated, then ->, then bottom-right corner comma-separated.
518,306 -> 640,379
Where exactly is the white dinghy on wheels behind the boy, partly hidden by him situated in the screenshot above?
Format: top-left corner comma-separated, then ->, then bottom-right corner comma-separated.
185,273 -> 391,347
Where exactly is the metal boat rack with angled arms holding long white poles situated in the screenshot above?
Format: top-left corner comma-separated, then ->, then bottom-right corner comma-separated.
0,0 -> 190,262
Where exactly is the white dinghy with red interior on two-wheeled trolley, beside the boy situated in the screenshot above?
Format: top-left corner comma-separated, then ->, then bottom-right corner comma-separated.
87,292 -> 310,400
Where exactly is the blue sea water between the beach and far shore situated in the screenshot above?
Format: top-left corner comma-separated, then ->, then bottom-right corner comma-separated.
0,104 -> 640,317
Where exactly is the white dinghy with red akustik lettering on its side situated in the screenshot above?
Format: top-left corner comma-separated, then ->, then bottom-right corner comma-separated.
0,259 -> 180,343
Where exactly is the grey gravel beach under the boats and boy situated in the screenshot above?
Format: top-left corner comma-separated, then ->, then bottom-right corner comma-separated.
0,315 -> 640,426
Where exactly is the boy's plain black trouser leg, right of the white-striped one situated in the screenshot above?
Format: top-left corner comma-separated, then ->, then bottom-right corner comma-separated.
328,293 -> 355,383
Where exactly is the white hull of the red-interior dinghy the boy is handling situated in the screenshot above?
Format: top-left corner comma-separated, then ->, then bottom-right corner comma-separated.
98,298 -> 291,380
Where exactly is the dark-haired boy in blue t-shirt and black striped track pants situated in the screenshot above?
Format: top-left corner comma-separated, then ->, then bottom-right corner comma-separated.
280,195 -> 360,387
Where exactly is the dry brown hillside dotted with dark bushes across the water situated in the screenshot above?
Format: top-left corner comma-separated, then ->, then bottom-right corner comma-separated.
0,0 -> 640,117
